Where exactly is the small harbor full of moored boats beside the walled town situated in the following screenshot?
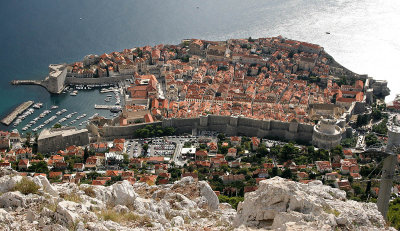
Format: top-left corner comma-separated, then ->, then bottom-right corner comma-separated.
1,84 -> 124,134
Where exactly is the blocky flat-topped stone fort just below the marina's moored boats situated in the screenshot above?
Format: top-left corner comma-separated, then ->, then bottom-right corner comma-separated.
38,128 -> 89,153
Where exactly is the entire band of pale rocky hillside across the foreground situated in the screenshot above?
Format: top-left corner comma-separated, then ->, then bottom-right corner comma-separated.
0,169 -> 394,231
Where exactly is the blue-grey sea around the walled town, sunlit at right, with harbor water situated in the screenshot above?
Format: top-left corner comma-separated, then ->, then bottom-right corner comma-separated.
0,0 -> 400,134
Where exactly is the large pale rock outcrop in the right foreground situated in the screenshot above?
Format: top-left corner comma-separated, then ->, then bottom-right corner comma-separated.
234,177 -> 394,230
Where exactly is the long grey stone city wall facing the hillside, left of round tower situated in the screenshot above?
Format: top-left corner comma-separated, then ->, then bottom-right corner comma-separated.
94,115 -> 334,143
